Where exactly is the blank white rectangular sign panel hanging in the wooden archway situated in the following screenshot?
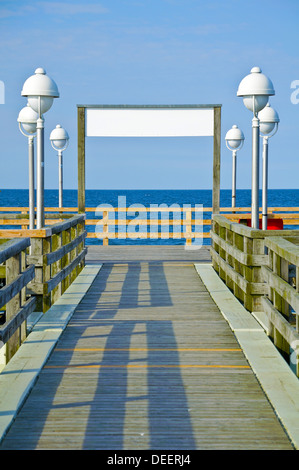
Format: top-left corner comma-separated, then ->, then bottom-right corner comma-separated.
86,108 -> 214,137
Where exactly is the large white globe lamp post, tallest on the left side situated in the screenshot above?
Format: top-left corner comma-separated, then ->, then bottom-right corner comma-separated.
21,67 -> 59,229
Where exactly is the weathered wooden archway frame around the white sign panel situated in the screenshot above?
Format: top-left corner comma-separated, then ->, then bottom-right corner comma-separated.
77,104 -> 221,214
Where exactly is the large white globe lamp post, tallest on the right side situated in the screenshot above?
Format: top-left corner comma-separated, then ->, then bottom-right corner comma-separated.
237,67 -> 275,228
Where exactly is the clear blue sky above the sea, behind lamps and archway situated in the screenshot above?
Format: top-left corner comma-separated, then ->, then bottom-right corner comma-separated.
0,0 -> 299,189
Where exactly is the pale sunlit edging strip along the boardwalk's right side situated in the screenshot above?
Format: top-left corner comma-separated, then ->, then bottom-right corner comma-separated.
194,264 -> 299,449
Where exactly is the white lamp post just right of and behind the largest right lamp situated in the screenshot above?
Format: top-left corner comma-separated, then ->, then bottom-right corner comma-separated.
258,103 -> 279,230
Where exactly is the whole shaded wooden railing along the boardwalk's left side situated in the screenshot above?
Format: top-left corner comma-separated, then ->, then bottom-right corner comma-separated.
0,214 -> 87,371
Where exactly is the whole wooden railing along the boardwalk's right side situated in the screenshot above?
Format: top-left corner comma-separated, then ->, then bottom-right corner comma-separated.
211,215 -> 299,376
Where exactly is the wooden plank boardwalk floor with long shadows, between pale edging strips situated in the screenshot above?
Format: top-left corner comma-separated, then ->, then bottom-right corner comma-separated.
0,247 -> 292,450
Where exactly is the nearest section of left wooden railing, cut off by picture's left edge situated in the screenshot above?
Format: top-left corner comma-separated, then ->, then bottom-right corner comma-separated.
0,238 -> 36,367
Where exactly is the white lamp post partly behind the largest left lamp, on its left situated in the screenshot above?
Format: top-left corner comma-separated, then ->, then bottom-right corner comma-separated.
18,104 -> 38,230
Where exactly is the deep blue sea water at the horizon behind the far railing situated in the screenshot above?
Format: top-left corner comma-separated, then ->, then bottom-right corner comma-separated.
0,189 -> 299,244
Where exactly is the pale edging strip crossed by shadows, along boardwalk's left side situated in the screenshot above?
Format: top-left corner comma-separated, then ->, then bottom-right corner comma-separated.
0,264 -> 102,442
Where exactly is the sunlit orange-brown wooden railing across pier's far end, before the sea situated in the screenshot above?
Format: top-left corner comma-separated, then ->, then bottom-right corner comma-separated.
0,206 -> 299,245
